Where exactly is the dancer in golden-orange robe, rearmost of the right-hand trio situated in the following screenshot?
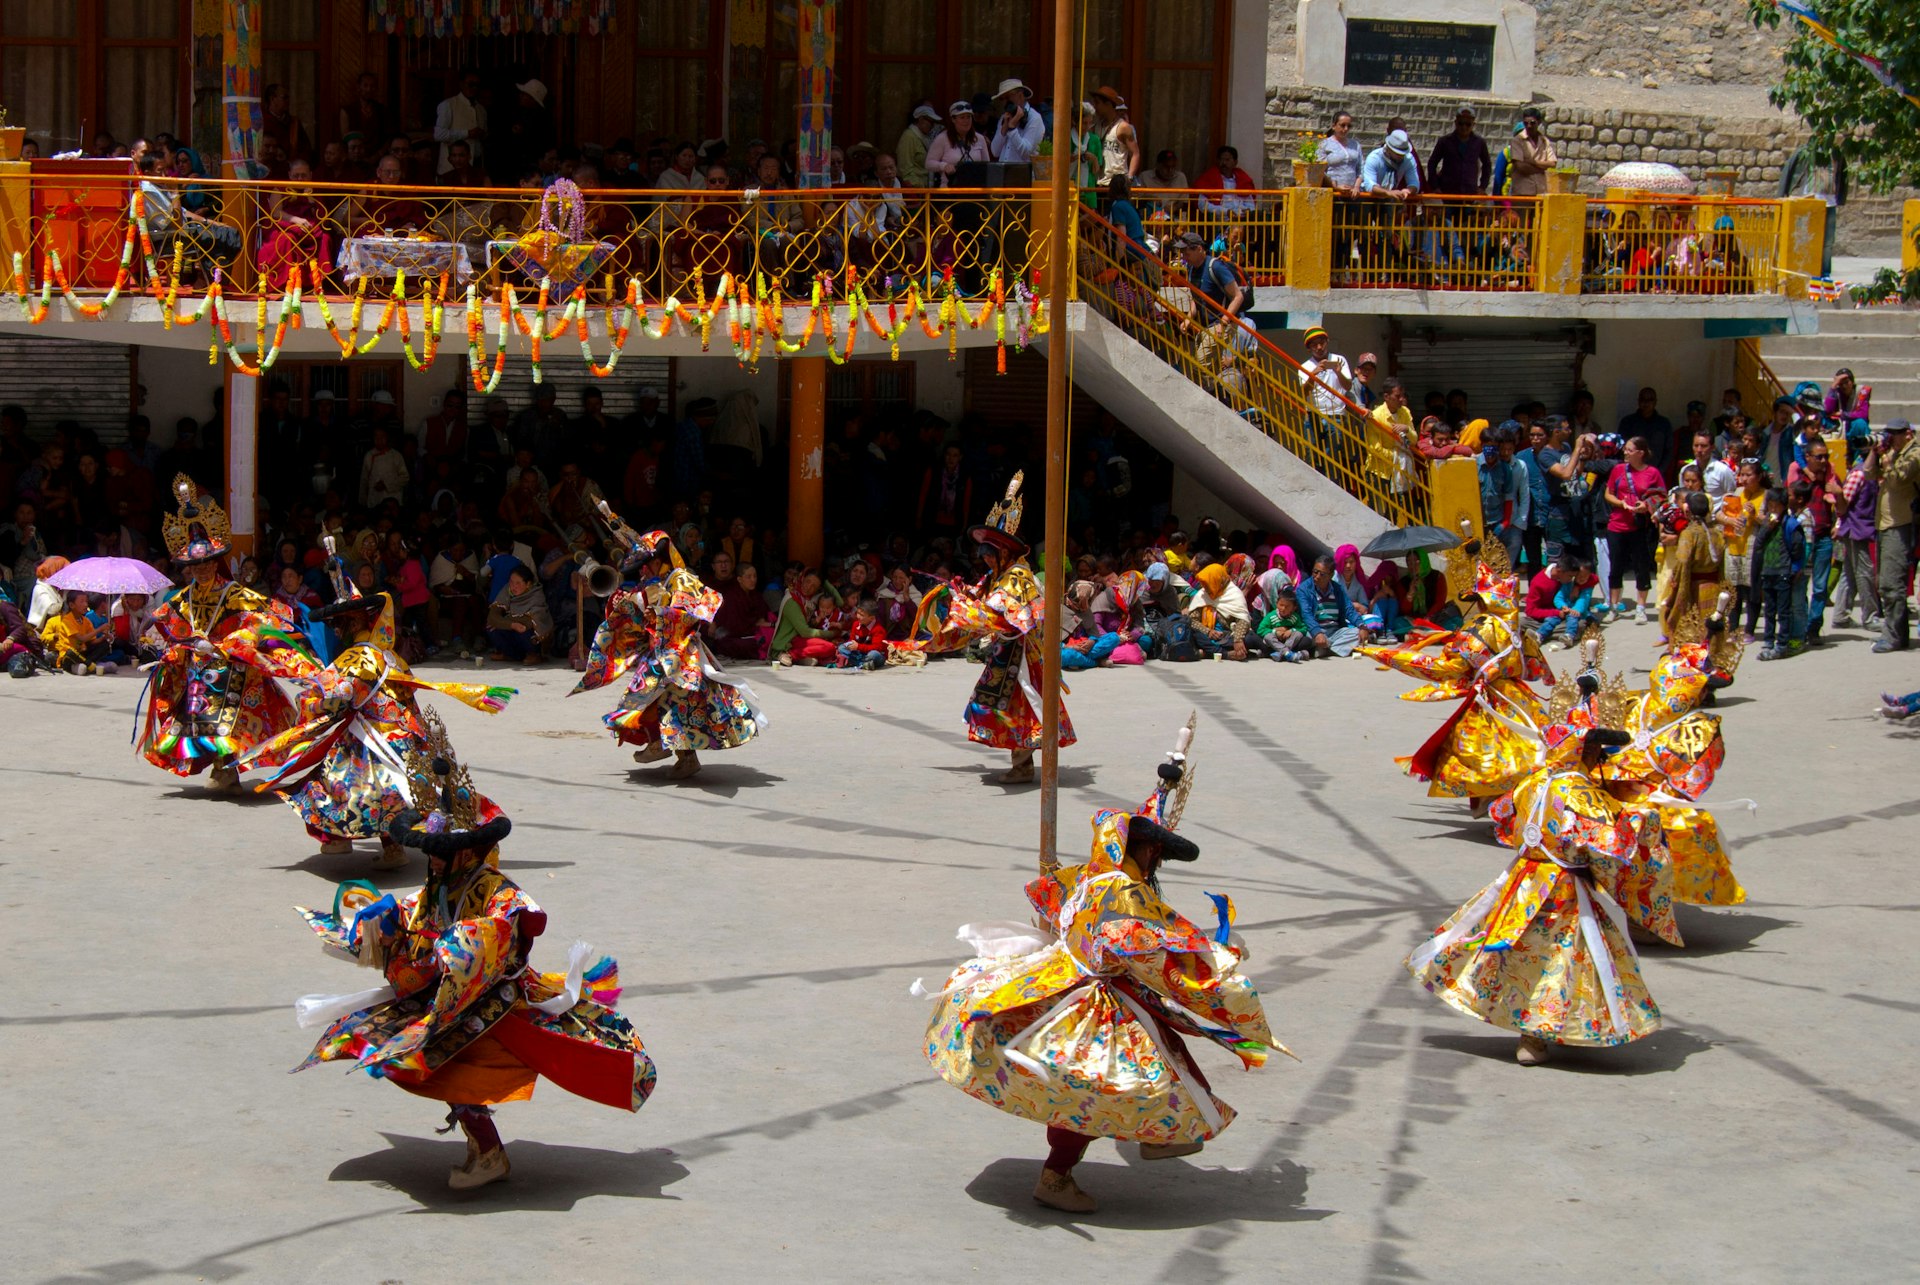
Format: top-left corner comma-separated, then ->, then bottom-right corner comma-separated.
1356,540 -> 1553,816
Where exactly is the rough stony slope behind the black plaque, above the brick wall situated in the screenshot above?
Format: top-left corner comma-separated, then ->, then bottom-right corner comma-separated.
1267,0 -> 1786,85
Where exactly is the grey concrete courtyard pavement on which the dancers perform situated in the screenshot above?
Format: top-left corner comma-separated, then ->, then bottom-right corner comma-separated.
0,624 -> 1920,1283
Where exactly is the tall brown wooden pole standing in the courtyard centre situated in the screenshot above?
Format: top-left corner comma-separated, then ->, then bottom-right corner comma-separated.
1041,0 -> 1077,874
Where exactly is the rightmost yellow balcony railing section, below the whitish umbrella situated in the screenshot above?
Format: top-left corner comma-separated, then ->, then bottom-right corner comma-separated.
1582,196 -> 1780,294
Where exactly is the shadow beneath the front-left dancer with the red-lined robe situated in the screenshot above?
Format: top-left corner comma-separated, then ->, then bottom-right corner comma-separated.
326,1131 -> 687,1214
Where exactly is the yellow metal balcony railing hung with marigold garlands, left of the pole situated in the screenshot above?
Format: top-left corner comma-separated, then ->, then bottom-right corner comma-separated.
3,177 -> 1046,302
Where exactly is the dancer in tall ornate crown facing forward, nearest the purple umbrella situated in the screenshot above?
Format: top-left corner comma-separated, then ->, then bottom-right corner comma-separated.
134,473 -> 319,789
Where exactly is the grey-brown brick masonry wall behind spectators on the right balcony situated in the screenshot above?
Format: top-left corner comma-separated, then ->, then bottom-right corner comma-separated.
1265,85 -> 1912,254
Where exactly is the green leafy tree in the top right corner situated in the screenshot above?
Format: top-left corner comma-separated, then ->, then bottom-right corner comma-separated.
1747,0 -> 1920,192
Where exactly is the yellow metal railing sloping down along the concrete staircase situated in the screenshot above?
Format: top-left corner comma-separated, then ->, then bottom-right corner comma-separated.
1079,211 -> 1432,526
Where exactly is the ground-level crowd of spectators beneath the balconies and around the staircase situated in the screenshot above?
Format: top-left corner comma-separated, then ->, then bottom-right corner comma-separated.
0,332 -> 1920,668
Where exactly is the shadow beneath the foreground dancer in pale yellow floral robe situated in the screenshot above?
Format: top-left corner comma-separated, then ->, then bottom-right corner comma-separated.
966,1143 -> 1332,1241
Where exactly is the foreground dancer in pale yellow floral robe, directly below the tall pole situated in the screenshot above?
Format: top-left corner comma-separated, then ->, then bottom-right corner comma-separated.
914,722 -> 1292,1212
